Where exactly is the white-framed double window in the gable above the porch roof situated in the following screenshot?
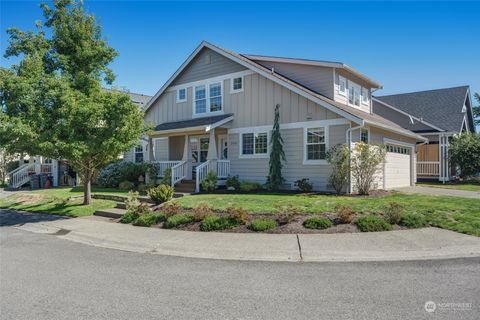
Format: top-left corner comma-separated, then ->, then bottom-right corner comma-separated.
194,82 -> 223,114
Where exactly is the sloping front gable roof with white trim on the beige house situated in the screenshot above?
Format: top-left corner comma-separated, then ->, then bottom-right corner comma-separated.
145,41 -> 426,140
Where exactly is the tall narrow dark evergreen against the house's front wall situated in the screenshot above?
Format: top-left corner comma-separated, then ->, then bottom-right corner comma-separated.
267,104 -> 286,190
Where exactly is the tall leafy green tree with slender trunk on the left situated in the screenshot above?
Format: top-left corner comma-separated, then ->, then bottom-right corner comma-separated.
0,0 -> 145,204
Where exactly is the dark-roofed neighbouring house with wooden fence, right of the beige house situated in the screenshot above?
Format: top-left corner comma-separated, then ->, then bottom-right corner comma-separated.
373,86 -> 475,181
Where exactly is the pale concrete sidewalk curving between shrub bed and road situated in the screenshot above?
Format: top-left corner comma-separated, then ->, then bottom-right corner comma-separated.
0,210 -> 480,262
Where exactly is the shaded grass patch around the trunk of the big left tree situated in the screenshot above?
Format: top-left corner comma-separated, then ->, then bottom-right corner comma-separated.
0,187 -> 128,217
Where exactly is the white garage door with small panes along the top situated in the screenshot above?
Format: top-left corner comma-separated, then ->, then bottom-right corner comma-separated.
385,145 -> 411,189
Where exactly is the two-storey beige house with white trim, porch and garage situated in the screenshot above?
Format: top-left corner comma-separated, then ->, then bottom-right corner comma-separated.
139,42 -> 427,191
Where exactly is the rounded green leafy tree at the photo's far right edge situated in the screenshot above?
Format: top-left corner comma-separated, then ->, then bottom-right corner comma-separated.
449,133 -> 480,178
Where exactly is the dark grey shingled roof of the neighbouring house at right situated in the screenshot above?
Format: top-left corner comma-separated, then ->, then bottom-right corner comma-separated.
376,86 -> 469,132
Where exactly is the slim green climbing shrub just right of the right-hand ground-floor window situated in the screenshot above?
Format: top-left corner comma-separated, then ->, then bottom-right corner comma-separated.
327,144 -> 350,194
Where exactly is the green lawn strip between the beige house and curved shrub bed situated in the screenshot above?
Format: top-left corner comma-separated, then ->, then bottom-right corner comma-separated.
176,193 -> 480,236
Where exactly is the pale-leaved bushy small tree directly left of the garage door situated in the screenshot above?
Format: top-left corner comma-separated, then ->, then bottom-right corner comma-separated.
350,142 -> 386,194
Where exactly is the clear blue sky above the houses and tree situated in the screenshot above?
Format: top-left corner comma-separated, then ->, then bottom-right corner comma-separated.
0,0 -> 480,104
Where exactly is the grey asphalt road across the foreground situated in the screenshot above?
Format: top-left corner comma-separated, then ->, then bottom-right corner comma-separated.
0,226 -> 480,320
